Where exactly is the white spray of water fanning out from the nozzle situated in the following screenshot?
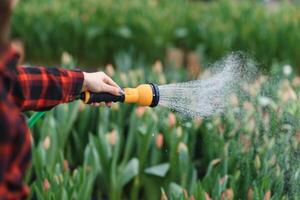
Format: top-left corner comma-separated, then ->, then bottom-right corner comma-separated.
159,53 -> 256,117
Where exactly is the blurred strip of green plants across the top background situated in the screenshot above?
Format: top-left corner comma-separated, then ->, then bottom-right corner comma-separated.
12,0 -> 300,68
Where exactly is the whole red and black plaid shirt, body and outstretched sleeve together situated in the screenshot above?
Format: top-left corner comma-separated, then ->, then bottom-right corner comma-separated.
0,49 -> 83,200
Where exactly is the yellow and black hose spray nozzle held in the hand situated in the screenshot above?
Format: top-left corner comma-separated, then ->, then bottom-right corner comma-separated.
79,83 -> 159,107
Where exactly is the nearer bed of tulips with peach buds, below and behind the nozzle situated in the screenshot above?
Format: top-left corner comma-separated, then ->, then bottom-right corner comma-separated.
27,55 -> 300,200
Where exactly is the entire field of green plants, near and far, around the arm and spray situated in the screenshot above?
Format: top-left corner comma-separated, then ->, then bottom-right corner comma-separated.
12,0 -> 300,200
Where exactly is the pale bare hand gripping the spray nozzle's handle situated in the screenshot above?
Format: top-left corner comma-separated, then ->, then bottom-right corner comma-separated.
82,72 -> 124,107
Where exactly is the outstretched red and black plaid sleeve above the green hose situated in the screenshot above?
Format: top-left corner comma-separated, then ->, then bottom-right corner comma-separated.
12,66 -> 84,111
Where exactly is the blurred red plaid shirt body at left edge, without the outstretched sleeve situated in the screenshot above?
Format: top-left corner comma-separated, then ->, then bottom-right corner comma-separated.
0,73 -> 31,200
